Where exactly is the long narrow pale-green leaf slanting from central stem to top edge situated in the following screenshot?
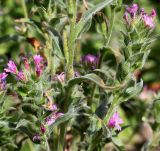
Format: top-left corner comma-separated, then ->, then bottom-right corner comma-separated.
75,0 -> 114,39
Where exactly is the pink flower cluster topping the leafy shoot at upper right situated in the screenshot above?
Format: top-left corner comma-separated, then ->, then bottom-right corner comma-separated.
124,4 -> 156,28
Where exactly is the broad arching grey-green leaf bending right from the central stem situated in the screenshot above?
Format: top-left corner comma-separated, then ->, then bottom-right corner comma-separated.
68,73 -> 105,88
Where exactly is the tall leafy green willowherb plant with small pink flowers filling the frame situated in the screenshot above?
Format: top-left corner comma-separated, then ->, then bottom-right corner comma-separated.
0,0 -> 156,151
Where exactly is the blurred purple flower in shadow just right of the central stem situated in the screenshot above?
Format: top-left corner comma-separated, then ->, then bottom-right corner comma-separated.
81,54 -> 99,69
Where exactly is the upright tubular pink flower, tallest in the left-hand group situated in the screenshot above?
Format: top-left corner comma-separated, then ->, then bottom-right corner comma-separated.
33,55 -> 44,77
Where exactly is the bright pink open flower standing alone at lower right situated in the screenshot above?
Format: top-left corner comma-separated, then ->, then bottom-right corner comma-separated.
108,111 -> 123,131
